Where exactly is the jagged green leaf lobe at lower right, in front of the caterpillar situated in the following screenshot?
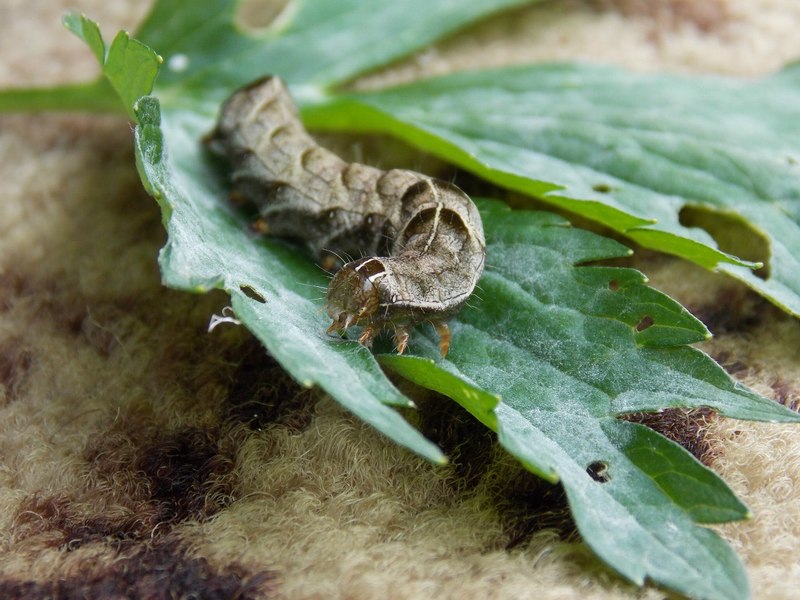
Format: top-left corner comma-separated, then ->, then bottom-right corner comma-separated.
380,202 -> 800,598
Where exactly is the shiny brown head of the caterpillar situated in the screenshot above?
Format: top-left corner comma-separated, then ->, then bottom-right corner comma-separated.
325,257 -> 386,332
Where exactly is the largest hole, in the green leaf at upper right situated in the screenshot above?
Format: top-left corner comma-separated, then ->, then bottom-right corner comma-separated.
678,205 -> 770,279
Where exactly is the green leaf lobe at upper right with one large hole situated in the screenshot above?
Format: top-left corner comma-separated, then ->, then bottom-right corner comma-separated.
305,64 -> 800,316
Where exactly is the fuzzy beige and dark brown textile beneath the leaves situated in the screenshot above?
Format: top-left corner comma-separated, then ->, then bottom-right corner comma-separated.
0,0 -> 800,600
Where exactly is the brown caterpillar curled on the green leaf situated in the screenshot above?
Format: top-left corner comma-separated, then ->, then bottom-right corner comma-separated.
207,77 -> 485,356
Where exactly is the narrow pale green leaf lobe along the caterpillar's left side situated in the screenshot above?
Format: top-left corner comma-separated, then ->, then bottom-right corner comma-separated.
135,97 -> 446,463
